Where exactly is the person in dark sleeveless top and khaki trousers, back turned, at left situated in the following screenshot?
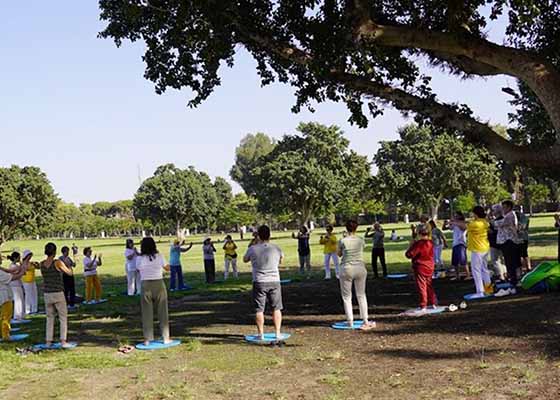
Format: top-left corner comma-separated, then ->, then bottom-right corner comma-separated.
39,243 -> 73,348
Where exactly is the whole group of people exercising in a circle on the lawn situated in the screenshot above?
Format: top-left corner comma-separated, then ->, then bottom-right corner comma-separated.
0,200 -> 560,348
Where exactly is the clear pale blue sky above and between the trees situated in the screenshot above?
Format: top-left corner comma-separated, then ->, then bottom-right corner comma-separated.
0,0 -> 514,203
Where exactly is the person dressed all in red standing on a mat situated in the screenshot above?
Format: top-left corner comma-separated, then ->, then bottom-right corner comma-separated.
405,227 -> 438,315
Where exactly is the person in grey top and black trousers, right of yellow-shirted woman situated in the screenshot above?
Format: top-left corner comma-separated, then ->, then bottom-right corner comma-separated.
494,200 -> 521,294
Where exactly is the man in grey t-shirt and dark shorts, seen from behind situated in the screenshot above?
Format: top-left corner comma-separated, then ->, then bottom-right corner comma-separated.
243,225 -> 284,340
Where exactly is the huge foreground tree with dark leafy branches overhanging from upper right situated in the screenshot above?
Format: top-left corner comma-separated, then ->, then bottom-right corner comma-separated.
99,0 -> 560,168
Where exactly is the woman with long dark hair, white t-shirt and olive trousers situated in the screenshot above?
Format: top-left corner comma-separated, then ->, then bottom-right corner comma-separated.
136,237 -> 171,346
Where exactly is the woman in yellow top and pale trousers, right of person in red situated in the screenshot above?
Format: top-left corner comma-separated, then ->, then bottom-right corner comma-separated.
467,206 -> 494,297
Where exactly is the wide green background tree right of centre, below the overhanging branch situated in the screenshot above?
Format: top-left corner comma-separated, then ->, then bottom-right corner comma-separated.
374,125 -> 507,218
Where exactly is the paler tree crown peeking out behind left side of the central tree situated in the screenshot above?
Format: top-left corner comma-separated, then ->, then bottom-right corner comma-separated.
229,132 -> 275,195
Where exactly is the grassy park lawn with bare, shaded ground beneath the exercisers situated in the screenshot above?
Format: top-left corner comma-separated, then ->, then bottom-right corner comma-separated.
0,215 -> 560,400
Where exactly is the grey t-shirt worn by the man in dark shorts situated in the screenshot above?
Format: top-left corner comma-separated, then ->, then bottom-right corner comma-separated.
245,243 -> 284,282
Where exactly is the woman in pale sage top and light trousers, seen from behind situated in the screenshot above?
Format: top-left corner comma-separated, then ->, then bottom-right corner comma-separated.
338,221 -> 375,330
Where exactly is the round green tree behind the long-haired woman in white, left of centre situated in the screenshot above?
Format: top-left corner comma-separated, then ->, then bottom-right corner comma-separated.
134,164 -> 218,235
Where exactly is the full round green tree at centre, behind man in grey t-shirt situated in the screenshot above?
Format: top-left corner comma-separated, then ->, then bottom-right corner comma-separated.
250,123 -> 370,223
